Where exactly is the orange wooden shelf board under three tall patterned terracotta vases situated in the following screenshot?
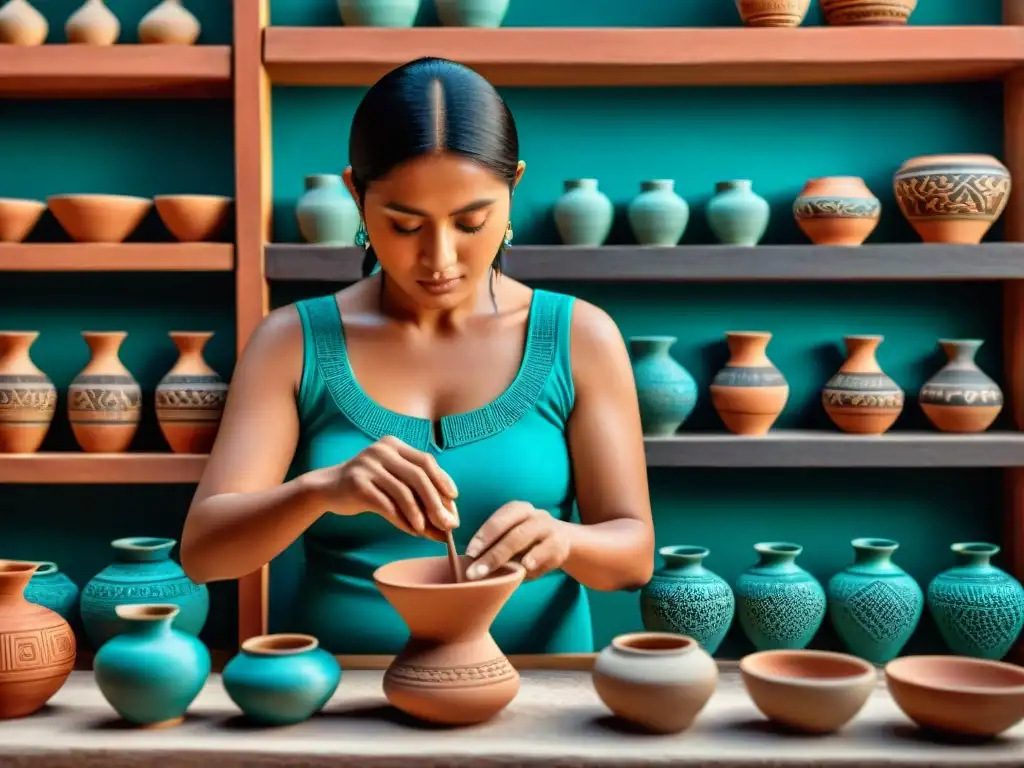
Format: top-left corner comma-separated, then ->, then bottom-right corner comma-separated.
0,452 -> 207,484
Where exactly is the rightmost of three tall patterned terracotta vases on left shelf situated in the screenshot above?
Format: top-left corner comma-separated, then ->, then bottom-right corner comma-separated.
156,331 -> 227,454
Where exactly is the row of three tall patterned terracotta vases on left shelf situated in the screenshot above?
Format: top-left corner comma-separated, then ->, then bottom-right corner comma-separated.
0,331 -> 228,454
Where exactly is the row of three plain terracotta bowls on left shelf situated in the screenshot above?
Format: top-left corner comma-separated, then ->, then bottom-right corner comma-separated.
0,195 -> 232,243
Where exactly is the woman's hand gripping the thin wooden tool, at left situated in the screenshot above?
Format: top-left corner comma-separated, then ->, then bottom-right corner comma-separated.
306,436 -> 459,542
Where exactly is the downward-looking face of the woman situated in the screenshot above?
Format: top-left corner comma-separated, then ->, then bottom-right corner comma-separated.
345,153 -> 524,308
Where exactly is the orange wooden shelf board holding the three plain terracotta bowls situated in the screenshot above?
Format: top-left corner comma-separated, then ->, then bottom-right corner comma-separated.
0,243 -> 234,272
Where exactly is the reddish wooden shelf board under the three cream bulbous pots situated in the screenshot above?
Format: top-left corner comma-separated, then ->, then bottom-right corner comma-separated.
0,44 -> 231,98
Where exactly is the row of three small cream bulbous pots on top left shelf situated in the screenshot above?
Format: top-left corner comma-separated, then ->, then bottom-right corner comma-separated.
0,0 -> 202,45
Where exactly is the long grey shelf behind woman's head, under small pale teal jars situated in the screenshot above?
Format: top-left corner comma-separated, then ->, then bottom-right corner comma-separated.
265,243 -> 1024,283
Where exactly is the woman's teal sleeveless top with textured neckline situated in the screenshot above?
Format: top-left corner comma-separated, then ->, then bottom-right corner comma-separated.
289,290 -> 593,654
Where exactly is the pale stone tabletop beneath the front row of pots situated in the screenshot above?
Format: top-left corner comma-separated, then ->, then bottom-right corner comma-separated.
0,670 -> 1024,768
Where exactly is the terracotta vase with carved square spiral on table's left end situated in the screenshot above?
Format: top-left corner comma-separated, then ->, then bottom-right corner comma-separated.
0,560 -> 77,719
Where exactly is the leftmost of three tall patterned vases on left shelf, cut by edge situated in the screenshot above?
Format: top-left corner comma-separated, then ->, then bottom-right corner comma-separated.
0,331 -> 57,454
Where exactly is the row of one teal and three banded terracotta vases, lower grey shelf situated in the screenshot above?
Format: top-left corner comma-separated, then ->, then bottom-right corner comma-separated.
629,331 -> 1004,436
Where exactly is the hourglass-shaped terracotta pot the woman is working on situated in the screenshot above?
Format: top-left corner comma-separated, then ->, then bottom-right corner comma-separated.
374,556 -> 525,725
